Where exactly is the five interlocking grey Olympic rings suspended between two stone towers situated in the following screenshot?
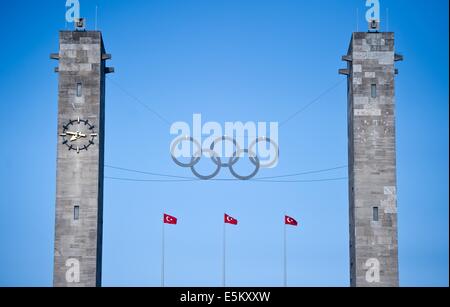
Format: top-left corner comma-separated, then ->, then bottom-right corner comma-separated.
170,136 -> 279,180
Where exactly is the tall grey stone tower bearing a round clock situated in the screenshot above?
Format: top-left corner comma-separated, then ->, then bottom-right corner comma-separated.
50,26 -> 113,287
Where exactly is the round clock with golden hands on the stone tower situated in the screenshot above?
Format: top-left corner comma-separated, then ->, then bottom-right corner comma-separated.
60,118 -> 98,154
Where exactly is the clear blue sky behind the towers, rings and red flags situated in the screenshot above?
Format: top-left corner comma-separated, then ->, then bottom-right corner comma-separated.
0,0 -> 449,286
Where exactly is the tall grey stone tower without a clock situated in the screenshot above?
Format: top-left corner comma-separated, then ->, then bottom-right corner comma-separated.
339,27 -> 402,287
